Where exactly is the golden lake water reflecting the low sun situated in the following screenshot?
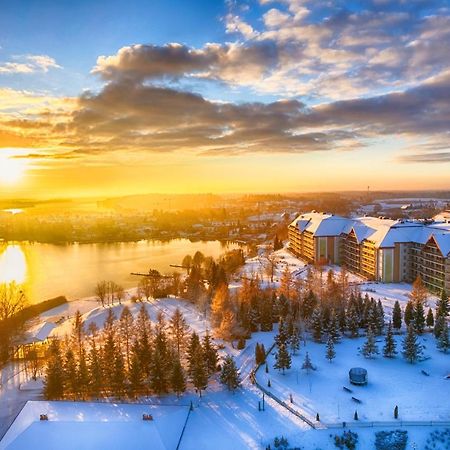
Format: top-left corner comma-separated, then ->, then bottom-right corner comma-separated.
0,239 -> 236,303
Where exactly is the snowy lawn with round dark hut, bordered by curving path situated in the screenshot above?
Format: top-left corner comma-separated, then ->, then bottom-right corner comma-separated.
257,334 -> 450,423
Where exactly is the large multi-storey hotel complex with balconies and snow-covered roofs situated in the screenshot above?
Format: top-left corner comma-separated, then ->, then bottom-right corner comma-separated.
289,211 -> 450,292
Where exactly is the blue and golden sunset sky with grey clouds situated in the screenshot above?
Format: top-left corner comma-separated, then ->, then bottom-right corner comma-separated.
0,0 -> 450,197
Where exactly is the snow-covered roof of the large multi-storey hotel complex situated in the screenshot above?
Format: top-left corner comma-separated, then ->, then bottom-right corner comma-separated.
291,211 -> 450,256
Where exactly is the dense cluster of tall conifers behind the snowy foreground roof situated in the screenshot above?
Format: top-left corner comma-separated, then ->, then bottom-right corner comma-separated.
45,305 -> 218,399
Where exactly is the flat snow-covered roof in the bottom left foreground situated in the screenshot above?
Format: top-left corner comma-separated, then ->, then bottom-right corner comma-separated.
0,401 -> 189,450
